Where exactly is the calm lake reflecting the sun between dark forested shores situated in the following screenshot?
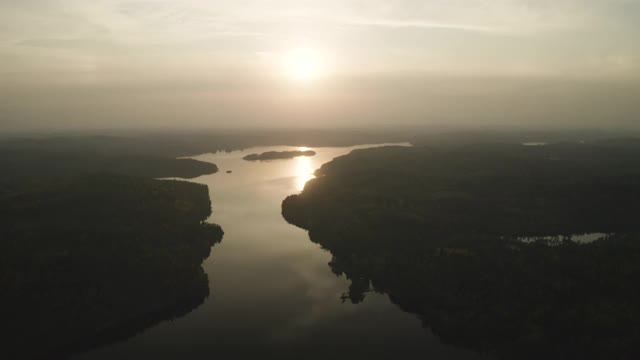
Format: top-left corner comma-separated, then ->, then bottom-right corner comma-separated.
75,146 -> 484,360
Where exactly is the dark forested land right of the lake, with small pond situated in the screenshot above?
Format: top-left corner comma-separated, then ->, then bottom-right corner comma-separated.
282,141 -> 640,359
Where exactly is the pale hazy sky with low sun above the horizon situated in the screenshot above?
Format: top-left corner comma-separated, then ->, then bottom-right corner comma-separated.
0,0 -> 640,129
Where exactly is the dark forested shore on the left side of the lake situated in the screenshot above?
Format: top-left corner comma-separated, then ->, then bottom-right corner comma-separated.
0,151 -> 223,359
